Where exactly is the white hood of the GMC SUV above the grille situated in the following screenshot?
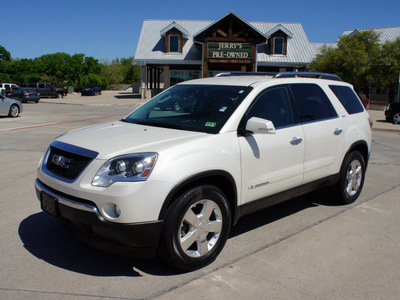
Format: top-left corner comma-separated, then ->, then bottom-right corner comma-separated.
57,121 -> 208,159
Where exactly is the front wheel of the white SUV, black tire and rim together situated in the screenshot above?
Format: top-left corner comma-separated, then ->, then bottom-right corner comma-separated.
158,185 -> 231,271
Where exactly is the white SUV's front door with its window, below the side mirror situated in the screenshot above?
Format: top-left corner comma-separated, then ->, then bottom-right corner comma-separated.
239,85 -> 305,204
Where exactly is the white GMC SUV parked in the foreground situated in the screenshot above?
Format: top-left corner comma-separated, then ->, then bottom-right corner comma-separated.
36,72 -> 372,270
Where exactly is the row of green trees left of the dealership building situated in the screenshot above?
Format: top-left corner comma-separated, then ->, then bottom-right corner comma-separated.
0,46 -> 140,90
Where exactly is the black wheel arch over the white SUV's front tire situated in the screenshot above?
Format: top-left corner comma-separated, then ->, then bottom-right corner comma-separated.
158,170 -> 237,223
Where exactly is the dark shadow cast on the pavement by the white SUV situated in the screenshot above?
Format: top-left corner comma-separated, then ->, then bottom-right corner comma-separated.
18,190 -> 337,277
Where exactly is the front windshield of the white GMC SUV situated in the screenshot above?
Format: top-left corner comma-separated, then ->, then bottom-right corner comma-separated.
123,84 -> 252,133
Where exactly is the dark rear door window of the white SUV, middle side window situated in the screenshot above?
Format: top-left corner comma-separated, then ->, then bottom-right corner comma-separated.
290,84 -> 337,123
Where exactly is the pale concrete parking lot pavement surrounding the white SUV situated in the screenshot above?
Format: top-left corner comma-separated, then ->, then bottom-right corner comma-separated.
0,92 -> 400,299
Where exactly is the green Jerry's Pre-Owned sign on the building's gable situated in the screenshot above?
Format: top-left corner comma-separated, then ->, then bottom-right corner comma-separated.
207,42 -> 253,59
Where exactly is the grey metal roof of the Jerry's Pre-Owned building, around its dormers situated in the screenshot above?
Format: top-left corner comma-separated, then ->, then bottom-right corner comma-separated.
135,20 -> 315,67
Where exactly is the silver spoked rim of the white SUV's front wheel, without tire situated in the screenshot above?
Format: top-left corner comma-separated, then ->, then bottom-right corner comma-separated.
179,200 -> 223,257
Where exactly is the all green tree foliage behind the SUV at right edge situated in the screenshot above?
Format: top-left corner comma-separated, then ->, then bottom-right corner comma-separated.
311,31 -> 400,99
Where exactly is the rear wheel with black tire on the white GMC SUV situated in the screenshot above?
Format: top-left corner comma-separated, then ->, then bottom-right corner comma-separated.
335,151 -> 365,204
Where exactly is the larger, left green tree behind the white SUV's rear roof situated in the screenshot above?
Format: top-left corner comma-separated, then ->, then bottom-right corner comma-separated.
311,30 -> 380,94
